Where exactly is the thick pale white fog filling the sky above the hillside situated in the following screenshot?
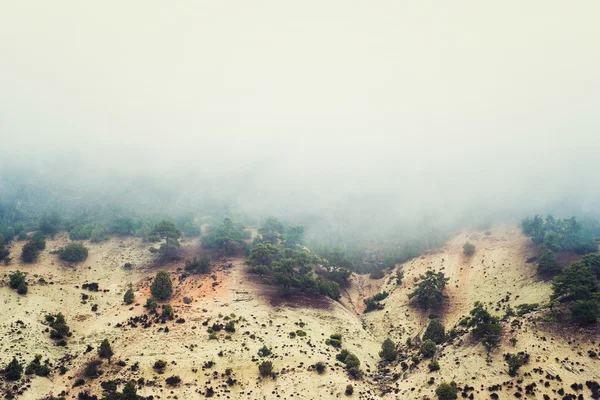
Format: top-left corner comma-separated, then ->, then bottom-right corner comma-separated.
0,0 -> 600,238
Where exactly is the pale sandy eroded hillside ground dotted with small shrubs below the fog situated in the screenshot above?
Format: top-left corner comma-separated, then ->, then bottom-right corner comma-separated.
0,226 -> 600,400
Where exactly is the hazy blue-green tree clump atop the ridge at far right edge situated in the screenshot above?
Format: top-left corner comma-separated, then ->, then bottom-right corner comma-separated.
521,215 -> 600,254
